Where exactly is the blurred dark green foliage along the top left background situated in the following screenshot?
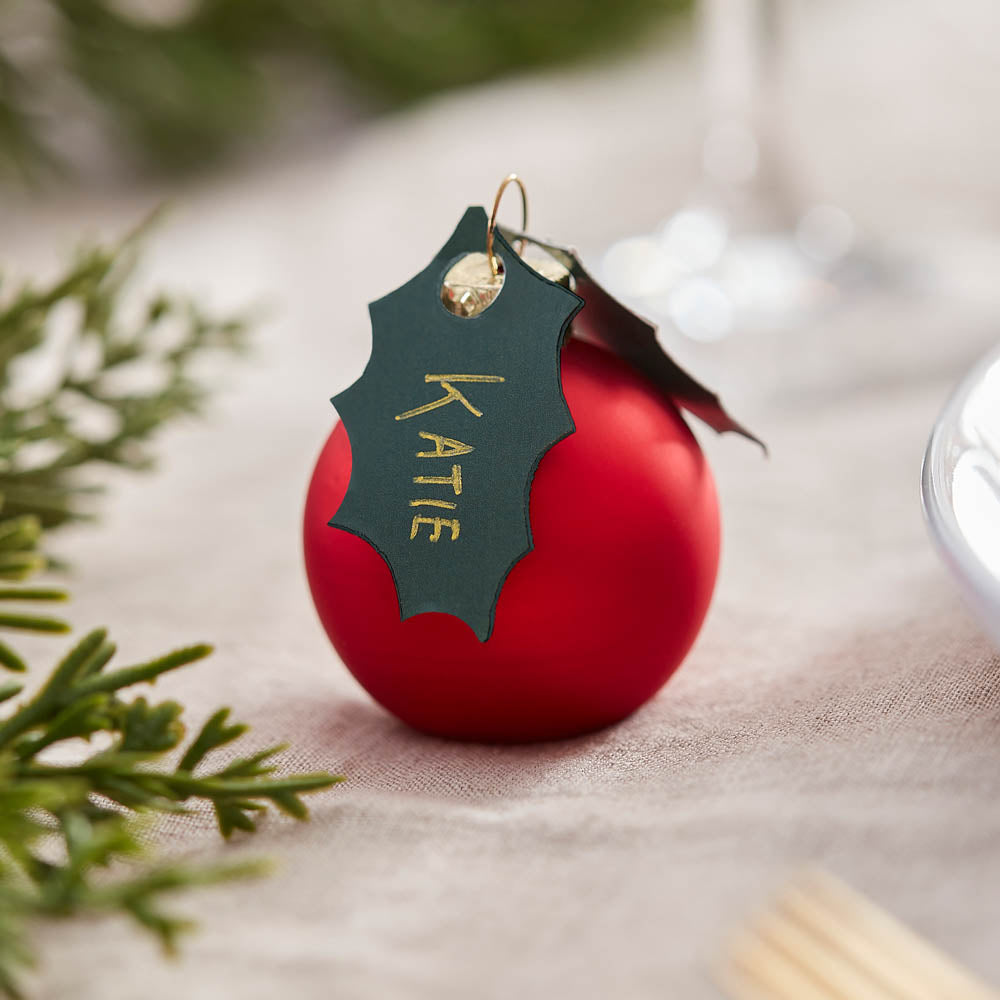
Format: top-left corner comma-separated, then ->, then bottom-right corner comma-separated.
0,0 -> 692,179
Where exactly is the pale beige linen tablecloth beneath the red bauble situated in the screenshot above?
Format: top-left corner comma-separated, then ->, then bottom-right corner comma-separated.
0,0 -> 1000,1000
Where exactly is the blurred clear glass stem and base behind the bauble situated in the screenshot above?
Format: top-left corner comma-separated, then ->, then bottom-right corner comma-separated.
600,0 -> 870,341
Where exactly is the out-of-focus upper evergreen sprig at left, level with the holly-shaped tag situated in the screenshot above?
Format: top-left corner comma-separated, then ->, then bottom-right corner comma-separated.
0,212 -> 246,536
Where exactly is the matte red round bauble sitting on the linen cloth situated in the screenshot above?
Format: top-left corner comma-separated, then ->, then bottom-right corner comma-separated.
305,340 -> 719,742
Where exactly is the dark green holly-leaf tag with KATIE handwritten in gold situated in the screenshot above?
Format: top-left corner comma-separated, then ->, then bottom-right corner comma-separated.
330,208 -> 583,642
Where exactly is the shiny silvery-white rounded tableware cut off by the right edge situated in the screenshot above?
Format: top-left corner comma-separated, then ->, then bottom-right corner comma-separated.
921,347 -> 1000,643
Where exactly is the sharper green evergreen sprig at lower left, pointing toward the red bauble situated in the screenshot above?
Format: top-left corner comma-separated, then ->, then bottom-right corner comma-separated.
0,629 -> 341,997
